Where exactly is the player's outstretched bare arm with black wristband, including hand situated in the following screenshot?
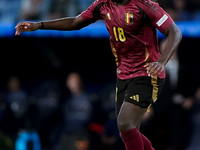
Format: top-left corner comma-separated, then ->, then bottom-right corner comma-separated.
15,15 -> 92,35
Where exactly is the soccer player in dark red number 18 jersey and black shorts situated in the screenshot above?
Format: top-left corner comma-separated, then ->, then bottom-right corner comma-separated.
15,0 -> 182,150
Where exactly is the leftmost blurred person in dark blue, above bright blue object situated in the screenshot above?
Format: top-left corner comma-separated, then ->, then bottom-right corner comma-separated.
4,76 -> 29,134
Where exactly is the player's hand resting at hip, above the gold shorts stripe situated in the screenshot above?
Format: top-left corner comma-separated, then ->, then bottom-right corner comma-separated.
144,62 -> 165,77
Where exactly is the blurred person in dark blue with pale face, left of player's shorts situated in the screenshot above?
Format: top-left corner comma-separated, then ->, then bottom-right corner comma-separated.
61,72 -> 91,150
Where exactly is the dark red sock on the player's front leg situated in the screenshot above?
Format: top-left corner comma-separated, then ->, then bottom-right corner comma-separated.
121,128 -> 144,150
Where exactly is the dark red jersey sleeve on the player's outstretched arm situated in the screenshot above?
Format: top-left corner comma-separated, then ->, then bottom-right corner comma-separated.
81,0 -> 102,21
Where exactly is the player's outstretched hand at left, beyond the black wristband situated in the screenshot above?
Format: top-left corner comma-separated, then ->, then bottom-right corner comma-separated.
15,22 -> 41,35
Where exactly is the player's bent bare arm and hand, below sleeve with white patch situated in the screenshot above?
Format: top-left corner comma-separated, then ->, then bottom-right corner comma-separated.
145,22 -> 182,76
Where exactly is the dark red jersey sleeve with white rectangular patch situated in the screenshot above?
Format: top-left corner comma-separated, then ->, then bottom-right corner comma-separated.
139,0 -> 173,33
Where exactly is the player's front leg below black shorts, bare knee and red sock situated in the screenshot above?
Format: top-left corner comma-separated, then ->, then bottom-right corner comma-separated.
117,102 -> 146,150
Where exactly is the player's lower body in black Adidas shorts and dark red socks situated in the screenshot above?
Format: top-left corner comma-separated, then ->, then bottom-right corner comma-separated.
116,78 -> 164,150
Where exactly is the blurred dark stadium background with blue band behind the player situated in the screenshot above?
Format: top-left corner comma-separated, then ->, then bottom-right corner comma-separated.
0,0 -> 200,150
